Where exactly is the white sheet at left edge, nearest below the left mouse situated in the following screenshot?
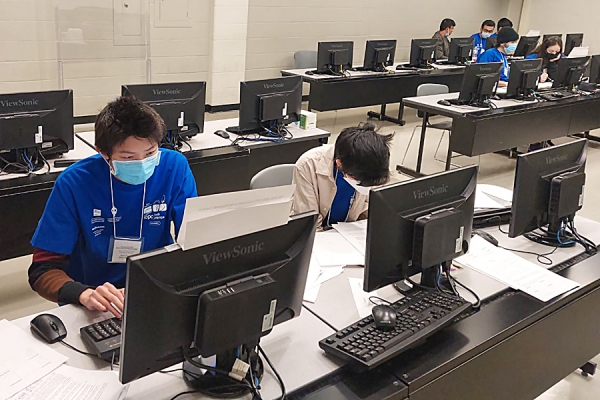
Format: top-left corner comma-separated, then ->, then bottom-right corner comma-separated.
0,320 -> 67,400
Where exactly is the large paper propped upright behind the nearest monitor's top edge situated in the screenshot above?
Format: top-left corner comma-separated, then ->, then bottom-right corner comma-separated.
177,185 -> 295,250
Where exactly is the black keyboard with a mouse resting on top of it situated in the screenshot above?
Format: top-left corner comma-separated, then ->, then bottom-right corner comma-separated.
319,291 -> 471,369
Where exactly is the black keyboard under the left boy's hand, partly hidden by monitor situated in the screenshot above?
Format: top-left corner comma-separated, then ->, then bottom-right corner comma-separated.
79,318 -> 121,362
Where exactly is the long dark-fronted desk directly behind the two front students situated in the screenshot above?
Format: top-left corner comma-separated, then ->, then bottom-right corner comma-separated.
0,118 -> 330,261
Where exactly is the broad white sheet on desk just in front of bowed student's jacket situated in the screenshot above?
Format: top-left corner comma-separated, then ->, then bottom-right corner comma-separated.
313,229 -> 365,267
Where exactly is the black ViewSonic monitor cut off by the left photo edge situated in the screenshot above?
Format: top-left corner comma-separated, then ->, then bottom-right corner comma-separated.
0,90 -> 75,172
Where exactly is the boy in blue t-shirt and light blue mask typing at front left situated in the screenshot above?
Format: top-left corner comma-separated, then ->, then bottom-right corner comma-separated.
28,97 -> 197,317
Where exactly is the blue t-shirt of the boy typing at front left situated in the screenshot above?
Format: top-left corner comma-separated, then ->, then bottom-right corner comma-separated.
31,149 -> 197,287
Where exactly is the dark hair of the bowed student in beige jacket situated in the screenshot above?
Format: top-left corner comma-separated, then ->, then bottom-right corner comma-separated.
335,122 -> 394,186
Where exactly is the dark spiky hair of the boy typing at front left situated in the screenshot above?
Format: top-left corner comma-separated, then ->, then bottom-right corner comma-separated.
95,96 -> 166,156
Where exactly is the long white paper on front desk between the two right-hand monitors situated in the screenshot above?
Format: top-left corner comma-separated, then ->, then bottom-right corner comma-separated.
455,235 -> 579,302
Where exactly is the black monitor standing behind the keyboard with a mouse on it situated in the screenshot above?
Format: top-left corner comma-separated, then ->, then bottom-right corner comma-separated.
363,166 -> 478,292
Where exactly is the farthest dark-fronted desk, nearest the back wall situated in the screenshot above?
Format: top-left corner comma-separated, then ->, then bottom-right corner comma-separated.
281,64 -> 464,125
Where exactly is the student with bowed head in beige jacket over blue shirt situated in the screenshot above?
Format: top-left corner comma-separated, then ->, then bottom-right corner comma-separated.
292,123 -> 393,230
